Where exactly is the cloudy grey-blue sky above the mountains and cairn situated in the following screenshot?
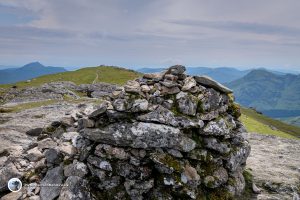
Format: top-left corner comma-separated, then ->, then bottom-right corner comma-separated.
0,0 -> 300,71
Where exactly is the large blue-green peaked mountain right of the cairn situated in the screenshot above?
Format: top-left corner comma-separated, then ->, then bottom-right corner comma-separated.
226,69 -> 300,118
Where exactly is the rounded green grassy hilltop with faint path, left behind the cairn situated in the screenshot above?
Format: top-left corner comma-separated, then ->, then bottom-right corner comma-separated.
0,66 -> 141,88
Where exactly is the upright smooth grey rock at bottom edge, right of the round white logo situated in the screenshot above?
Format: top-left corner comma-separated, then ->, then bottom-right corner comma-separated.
40,167 -> 64,200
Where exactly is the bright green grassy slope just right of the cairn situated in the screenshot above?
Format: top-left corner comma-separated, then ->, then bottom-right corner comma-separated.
240,108 -> 300,139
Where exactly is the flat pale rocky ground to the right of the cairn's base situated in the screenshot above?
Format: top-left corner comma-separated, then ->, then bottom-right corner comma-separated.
247,133 -> 300,200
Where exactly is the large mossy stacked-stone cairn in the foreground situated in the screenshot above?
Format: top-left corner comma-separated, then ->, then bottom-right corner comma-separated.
78,65 -> 250,199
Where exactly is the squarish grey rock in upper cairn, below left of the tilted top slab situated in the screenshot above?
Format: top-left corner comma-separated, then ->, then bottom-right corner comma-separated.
176,92 -> 198,116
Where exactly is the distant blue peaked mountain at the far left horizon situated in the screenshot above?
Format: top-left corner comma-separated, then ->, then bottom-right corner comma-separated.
0,62 -> 67,84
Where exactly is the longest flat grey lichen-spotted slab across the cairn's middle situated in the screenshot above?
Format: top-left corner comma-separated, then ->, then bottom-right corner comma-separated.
81,122 -> 195,151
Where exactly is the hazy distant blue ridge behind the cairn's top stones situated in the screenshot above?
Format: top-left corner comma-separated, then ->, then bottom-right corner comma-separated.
137,67 -> 250,83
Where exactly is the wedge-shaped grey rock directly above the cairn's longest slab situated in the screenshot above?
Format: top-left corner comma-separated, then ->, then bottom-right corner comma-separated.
137,106 -> 178,127
